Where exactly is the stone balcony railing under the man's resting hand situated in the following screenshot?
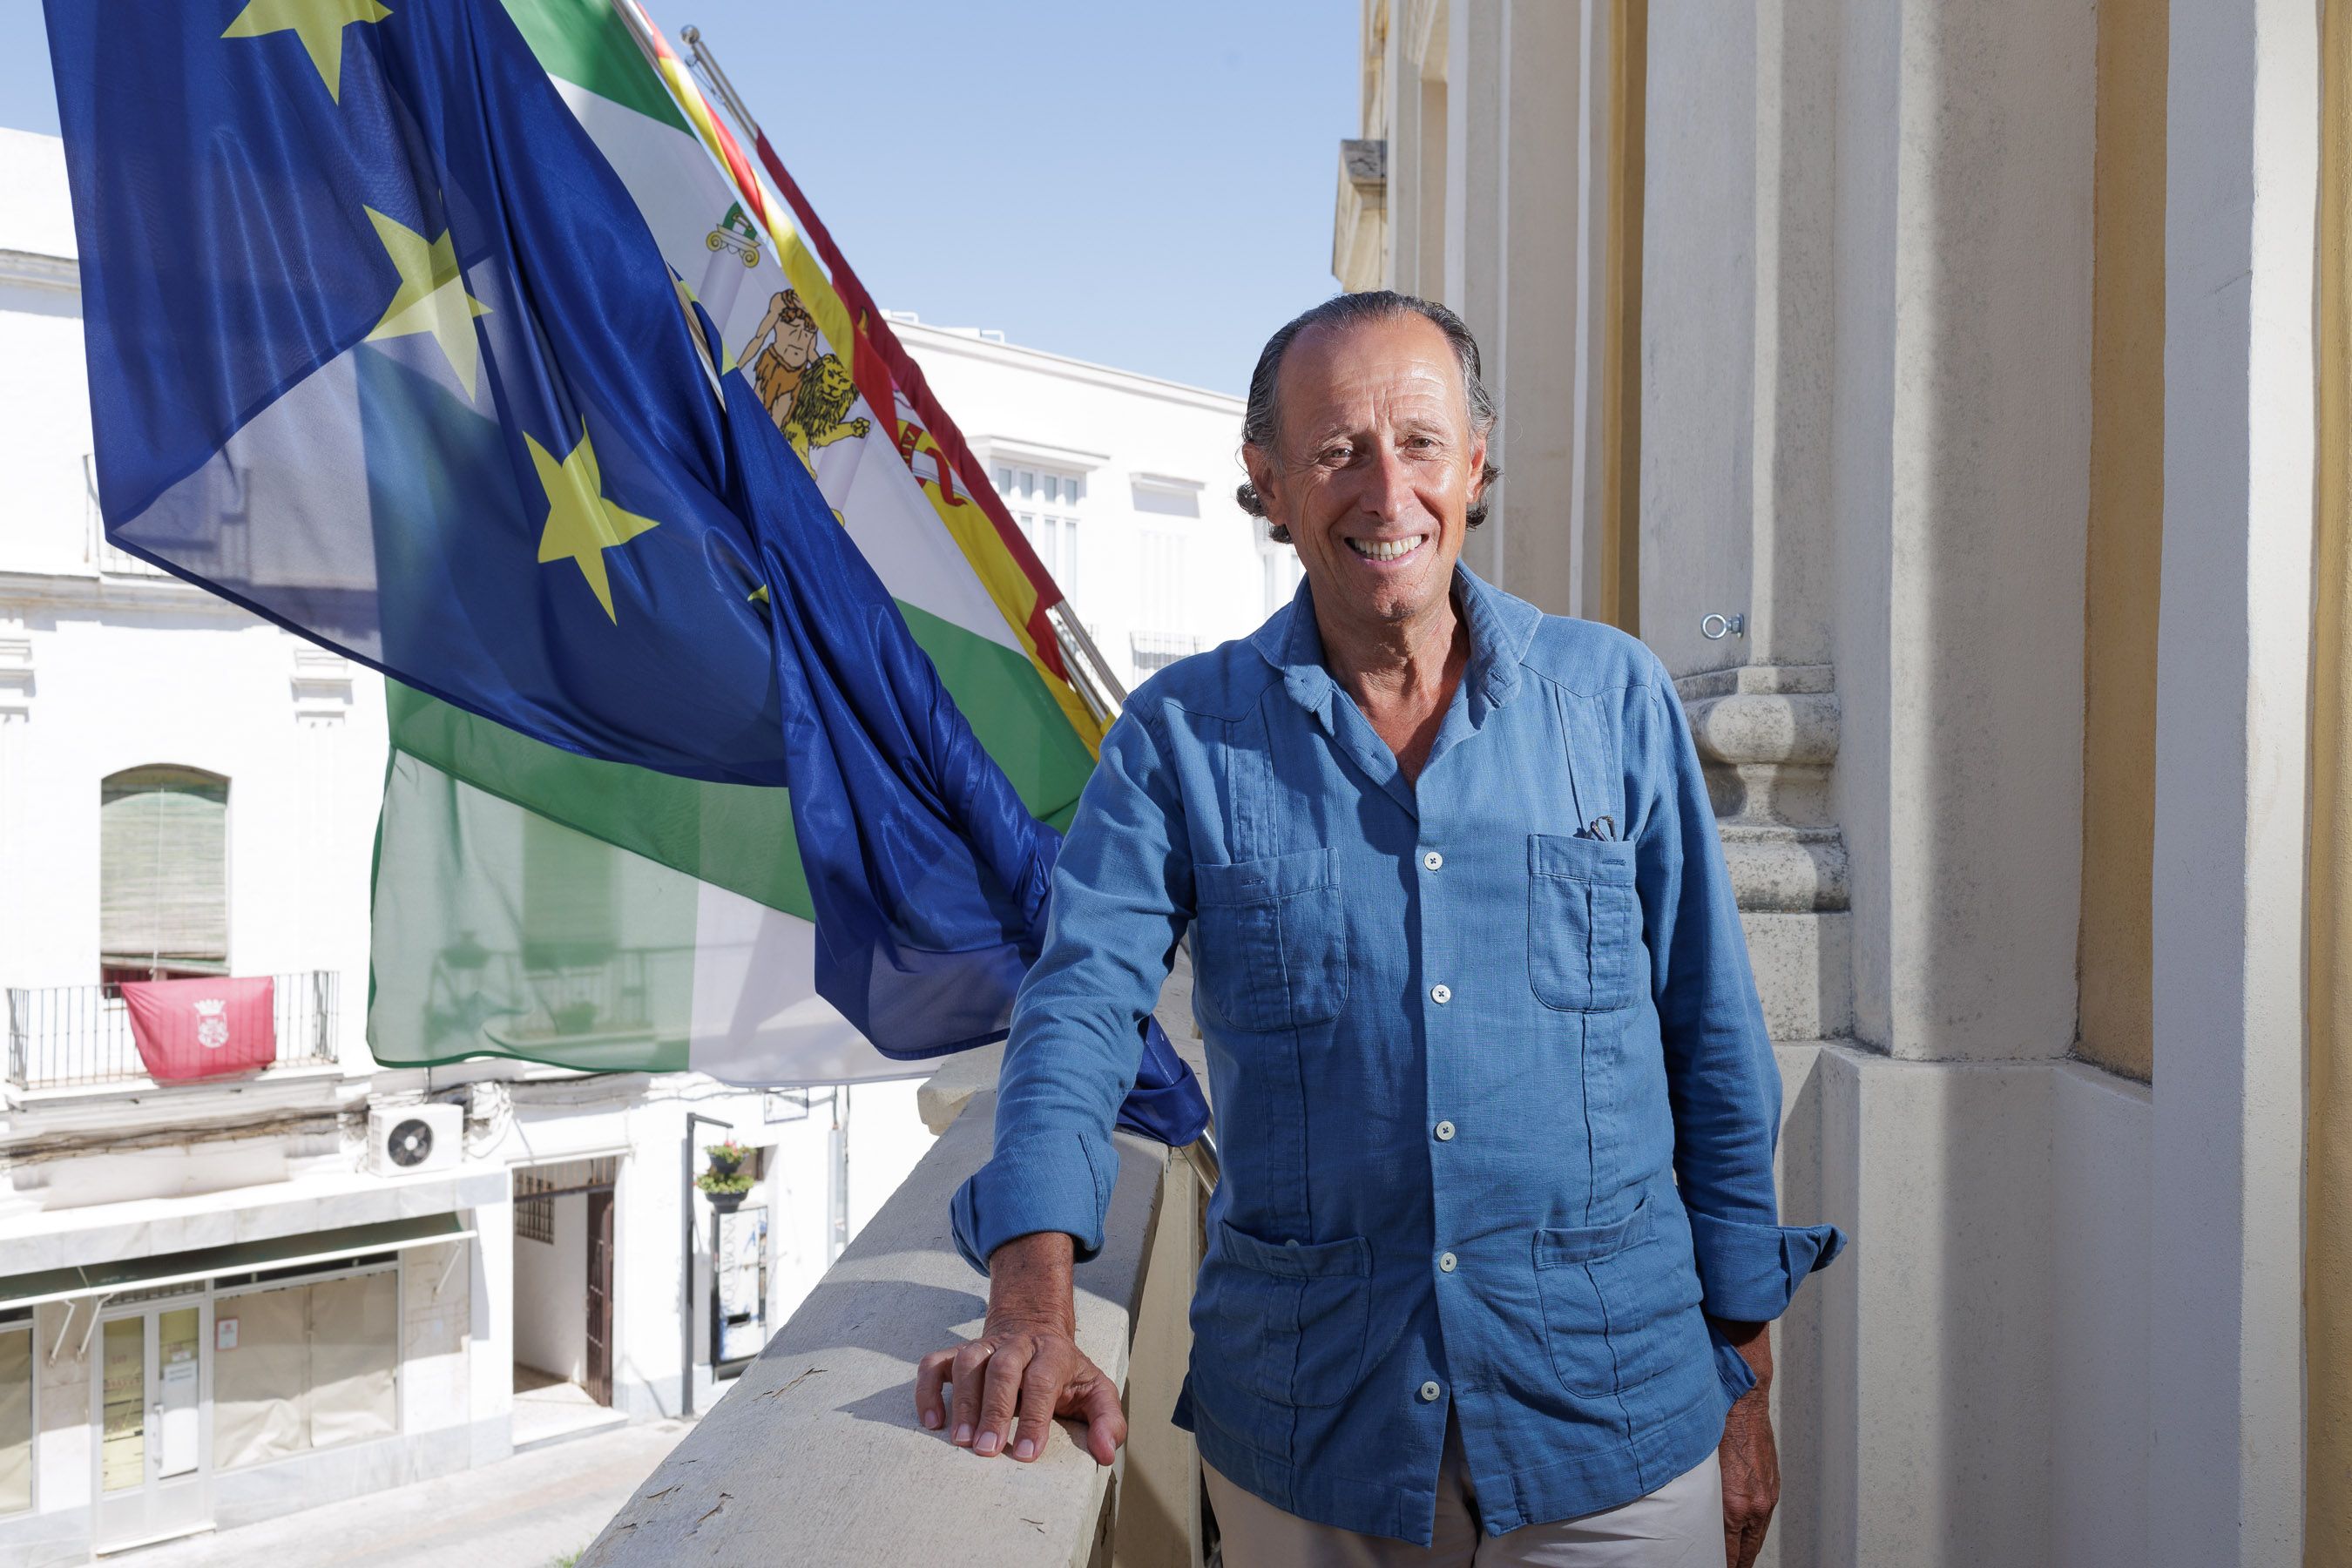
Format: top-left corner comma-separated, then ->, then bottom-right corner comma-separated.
581,971 -> 1202,1568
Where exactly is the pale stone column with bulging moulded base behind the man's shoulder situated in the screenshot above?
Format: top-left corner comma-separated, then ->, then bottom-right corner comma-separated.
1642,0 -> 1854,1042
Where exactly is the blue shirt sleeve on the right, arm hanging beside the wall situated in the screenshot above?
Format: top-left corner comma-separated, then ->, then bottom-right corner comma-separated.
1625,666 -> 1847,1323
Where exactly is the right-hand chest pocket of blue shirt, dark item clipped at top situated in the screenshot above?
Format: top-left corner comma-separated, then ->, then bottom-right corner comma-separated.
1526,832 -> 1642,1013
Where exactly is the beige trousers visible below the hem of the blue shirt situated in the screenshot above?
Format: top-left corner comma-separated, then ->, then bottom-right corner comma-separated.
1202,1420 -> 1724,1568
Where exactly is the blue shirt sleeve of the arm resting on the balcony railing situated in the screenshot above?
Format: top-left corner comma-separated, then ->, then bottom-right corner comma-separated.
948,689 -> 1193,1274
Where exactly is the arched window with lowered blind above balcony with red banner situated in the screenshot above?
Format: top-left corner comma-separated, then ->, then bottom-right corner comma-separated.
98,767 -> 228,973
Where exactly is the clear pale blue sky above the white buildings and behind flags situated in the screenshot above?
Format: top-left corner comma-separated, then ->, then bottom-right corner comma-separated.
0,0 -> 1360,393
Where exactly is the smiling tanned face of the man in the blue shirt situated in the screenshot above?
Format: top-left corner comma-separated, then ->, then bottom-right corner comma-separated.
1242,315 -> 1486,632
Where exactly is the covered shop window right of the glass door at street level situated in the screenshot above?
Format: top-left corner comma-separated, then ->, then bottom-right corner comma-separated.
212,1269 -> 400,1470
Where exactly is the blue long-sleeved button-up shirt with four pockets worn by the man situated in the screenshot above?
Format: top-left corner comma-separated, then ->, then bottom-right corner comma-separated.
950,566 -> 1844,1544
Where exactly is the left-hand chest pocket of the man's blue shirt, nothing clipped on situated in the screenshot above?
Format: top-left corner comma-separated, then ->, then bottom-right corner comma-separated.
1193,848 -> 1348,1032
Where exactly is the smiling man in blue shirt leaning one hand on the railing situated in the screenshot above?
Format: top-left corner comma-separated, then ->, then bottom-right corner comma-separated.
915,294 -> 1842,1568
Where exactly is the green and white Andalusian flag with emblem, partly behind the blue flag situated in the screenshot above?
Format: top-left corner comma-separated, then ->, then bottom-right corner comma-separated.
367,0 -> 1094,1086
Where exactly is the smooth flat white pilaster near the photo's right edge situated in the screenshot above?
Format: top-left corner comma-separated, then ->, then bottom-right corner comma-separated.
2147,0 -> 2322,1568
